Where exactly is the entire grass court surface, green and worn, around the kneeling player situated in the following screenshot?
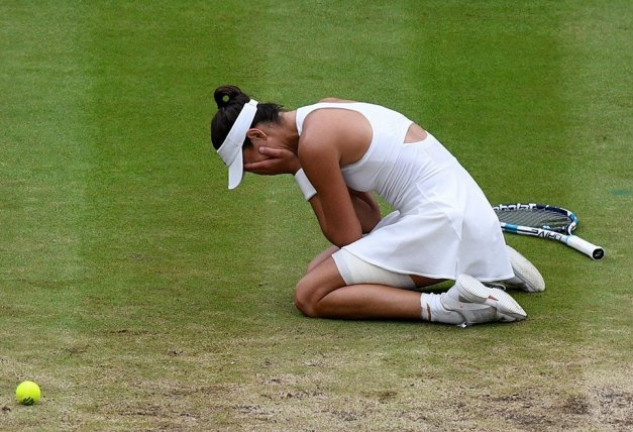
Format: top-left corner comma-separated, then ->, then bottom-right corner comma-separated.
0,0 -> 633,431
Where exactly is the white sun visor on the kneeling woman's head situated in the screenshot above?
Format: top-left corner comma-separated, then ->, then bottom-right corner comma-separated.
218,99 -> 258,189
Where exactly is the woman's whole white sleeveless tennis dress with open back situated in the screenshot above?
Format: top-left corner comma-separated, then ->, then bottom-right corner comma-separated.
297,103 -> 514,282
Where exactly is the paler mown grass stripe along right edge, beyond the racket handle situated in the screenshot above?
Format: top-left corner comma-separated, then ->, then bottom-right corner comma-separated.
559,1 -> 633,398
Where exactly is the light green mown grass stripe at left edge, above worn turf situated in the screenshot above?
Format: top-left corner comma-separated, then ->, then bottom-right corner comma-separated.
0,3 -> 91,328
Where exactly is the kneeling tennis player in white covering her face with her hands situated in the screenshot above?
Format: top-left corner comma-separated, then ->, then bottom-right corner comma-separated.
211,86 -> 545,325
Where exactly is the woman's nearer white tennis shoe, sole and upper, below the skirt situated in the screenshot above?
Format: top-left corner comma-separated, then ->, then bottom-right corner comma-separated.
440,275 -> 527,326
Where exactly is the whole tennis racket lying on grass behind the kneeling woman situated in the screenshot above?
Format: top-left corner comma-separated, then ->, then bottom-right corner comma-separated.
492,203 -> 604,260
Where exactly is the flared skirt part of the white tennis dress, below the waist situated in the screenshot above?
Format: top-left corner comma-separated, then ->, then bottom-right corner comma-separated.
344,160 -> 514,282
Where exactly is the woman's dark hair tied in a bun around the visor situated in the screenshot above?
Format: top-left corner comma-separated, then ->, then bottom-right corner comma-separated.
211,85 -> 283,150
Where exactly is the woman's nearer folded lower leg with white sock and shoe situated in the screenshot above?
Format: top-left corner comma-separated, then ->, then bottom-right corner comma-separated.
295,257 -> 526,325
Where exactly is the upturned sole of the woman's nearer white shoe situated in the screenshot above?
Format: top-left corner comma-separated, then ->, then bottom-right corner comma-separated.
456,275 -> 527,322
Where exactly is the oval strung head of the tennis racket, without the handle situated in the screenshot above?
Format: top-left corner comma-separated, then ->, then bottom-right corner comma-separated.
492,203 -> 578,235
